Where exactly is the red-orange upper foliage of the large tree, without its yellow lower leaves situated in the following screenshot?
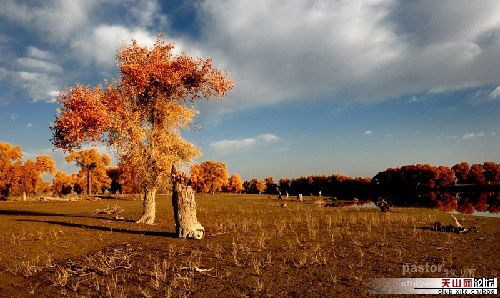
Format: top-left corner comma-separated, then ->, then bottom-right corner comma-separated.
51,36 -> 232,154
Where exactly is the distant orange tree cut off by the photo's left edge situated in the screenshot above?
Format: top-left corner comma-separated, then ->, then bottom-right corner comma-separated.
0,143 -> 22,197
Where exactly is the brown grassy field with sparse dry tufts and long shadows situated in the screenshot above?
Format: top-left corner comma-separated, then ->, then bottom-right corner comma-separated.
0,195 -> 500,297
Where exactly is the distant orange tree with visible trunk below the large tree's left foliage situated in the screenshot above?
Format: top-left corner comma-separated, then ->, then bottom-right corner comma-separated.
66,148 -> 111,195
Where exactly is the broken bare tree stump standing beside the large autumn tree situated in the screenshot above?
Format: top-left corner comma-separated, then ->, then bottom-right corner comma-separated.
172,182 -> 205,239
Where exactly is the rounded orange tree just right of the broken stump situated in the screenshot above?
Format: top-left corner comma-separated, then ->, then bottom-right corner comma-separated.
191,161 -> 228,193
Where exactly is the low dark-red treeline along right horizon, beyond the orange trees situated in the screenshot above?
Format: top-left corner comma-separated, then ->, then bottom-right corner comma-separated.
243,162 -> 500,196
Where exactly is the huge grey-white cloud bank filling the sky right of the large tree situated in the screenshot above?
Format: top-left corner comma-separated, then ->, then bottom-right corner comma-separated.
193,0 -> 500,110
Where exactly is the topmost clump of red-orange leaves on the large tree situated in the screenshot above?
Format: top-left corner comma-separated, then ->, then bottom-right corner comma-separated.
117,38 -> 233,100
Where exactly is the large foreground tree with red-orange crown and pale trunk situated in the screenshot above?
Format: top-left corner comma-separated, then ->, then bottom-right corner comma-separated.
52,37 -> 232,228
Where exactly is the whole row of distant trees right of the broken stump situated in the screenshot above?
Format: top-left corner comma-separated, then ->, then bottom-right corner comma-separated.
185,161 -> 500,196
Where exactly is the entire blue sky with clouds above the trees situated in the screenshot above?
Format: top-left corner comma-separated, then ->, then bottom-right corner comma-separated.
0,0 -> 500,180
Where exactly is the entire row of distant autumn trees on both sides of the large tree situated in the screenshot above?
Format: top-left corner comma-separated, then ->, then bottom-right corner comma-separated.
0,143 -> 500,197
